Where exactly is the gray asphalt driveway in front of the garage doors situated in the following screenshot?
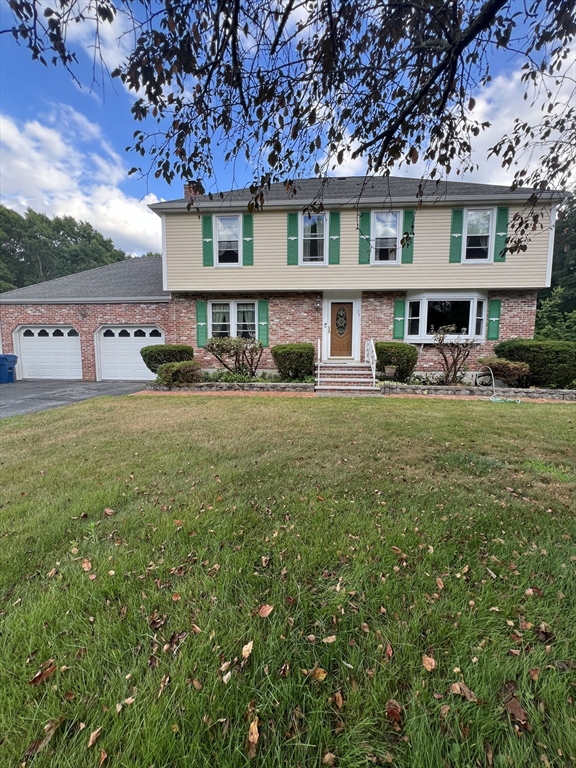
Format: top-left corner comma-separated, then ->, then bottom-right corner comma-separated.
0,379 -> 146,419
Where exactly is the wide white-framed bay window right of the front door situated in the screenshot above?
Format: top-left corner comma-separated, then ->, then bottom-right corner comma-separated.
405,294 -> 487,342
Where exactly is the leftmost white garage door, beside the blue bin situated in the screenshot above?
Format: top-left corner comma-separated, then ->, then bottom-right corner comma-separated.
18,325 -> 82,379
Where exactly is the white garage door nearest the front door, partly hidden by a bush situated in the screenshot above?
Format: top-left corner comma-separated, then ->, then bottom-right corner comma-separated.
96,325 -> 164,381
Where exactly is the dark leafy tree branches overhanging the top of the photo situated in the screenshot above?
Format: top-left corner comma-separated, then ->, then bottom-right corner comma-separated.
3,0 -> 576,218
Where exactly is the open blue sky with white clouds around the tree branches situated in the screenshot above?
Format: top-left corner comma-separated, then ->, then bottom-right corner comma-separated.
0,5 -> 576,254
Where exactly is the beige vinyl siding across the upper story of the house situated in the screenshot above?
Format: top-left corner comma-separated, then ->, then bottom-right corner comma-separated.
166,205 -> 549,292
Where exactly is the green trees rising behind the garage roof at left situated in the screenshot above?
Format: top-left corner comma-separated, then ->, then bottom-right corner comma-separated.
0,206 -> 126,291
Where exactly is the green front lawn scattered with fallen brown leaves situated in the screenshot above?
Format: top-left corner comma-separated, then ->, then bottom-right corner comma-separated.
0,396 -> 576,768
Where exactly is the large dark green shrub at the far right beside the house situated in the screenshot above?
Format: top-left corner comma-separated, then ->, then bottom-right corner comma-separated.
494,339 -> 576,389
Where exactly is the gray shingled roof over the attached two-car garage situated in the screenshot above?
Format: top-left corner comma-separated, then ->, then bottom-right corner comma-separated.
0,256 -> 170,304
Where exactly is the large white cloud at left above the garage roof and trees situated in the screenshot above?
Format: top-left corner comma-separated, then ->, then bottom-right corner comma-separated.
0,105 -> 161,253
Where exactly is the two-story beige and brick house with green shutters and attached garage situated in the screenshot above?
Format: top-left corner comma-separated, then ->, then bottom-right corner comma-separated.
0,177 -> 562,378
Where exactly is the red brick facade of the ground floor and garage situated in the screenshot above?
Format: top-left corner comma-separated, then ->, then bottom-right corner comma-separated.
0,291 -> 536,380
